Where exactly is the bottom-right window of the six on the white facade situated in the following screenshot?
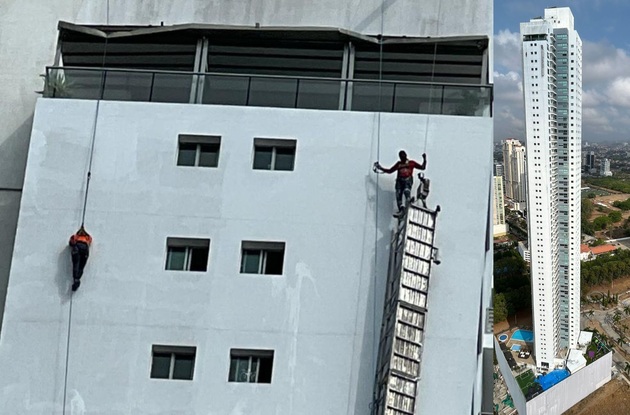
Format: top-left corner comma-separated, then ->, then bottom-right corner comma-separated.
228,349 -> 274,383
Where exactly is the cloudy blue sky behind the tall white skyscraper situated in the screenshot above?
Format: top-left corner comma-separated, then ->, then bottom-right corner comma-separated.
494,0 -> 630,142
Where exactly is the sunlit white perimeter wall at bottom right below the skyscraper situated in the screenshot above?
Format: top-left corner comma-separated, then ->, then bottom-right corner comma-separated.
519,352 -> 612,415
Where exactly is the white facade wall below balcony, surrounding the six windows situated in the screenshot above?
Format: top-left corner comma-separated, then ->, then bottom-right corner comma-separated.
0,99 -> 492,415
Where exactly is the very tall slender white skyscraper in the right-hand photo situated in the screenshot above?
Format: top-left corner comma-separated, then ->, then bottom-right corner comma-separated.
521,7 -> 582,369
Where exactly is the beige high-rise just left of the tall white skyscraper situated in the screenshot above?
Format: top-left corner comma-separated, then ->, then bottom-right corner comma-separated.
502,138 -> 527,209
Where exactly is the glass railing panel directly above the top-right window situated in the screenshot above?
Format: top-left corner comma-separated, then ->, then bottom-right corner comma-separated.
247,78 -> 297,108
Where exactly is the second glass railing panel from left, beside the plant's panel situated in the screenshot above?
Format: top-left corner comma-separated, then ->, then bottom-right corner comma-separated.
103,71 -> 152,101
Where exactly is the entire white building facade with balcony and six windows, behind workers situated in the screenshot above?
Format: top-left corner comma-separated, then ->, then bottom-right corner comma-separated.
0,0 -> 493,415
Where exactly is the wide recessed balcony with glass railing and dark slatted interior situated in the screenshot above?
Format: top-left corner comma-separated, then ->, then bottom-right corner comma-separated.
44,22 -> 492,116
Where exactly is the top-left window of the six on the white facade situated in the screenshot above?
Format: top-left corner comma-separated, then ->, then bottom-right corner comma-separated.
177,134 -> 221,167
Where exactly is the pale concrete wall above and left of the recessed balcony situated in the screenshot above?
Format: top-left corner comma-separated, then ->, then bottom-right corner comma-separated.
0,0 -> 492,334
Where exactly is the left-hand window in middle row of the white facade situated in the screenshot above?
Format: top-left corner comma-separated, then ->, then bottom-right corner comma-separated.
166,238 -> 210,272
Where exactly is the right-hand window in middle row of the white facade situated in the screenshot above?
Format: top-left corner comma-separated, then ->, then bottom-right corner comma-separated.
241,241 -> 285,275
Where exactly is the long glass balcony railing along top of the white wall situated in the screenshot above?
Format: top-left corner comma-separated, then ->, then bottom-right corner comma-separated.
43,67 -> 492,117
